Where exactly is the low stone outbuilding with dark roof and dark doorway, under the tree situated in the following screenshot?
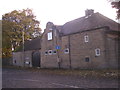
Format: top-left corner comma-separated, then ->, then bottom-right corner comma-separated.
13,38 -> 41,67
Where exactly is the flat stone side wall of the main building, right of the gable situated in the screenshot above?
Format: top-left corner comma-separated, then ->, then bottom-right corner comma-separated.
62,29 -> 106,69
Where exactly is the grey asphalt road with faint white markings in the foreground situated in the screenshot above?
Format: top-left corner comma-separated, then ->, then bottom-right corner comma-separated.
2,68 -> 118,89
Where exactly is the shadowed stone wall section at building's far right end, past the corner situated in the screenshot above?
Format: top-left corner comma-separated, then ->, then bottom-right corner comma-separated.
106,34 -> 120,68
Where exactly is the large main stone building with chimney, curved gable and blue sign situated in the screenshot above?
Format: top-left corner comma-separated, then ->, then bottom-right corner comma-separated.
41,9 -> 120,69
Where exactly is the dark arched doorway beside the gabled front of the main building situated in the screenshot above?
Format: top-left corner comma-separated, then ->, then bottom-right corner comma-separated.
32,51 -> 40,67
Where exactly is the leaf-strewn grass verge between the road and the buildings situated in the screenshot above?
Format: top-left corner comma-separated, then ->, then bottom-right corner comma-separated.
4,66 -> 120,78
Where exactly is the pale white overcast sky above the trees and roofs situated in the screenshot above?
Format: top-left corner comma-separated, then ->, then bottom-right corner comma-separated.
0,0 -> 116,30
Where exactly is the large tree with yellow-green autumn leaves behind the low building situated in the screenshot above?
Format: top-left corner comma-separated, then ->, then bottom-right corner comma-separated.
2,9 -> 41,56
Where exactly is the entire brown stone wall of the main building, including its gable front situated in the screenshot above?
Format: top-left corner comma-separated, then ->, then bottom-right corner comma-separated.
41,24 -> 118,69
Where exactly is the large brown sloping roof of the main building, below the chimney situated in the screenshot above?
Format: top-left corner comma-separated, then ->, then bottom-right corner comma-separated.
61,13 -> 120,35
